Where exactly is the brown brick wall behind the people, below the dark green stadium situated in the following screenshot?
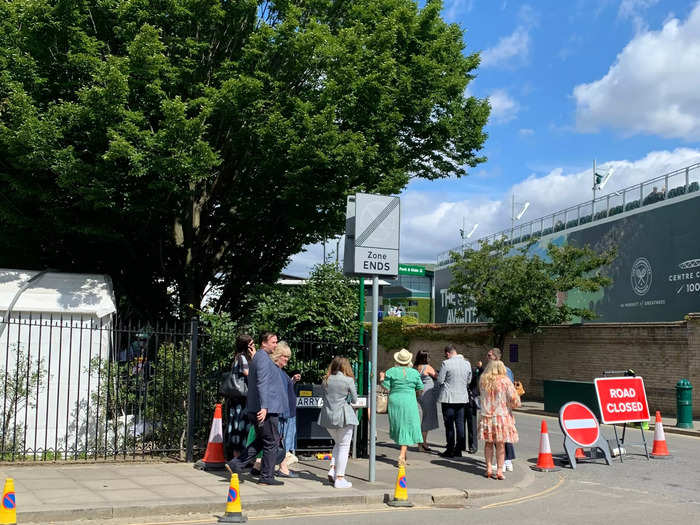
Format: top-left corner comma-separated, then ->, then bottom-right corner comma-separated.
378,313 -> 700,418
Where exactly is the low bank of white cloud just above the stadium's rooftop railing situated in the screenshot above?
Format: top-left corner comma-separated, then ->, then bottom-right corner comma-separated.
285,148 -> 700,275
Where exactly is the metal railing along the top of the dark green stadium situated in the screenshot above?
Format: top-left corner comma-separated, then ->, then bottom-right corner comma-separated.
437,163 -> 700,268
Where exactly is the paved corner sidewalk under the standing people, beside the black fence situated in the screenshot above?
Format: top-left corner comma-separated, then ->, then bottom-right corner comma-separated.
0,402 -> 700,523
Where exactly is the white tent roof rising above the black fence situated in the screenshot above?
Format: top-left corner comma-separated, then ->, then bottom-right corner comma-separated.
0,268 -> 117,318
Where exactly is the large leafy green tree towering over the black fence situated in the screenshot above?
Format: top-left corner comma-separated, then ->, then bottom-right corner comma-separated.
0,0 -> 489,315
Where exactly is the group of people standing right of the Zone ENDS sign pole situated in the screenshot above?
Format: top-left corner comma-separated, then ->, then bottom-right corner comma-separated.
379,345 -> 520,480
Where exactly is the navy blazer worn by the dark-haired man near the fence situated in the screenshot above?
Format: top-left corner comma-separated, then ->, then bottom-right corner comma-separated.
246,349 -> 289,415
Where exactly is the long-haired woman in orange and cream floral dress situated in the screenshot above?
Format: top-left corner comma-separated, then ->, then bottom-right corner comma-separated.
479,360 -> 520,479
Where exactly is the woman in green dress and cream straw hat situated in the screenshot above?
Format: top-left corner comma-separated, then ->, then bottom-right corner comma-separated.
379,348 -> 423,465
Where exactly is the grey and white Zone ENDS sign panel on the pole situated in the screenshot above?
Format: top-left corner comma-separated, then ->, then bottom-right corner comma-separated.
343,193 -> 401,277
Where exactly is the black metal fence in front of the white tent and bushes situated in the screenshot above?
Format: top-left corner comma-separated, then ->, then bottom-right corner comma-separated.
0,313 -> 358,461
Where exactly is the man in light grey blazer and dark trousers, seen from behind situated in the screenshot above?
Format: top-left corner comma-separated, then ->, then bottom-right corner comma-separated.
437,344 -> 472,458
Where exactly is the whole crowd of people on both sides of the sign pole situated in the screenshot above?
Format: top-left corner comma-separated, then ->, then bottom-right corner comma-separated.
225,332 -> 520,488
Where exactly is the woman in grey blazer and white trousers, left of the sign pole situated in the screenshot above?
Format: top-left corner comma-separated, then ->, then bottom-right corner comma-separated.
318,357 -> 359,489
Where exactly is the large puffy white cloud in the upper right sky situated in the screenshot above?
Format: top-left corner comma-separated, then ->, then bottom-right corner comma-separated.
573,4 -> 700,141
